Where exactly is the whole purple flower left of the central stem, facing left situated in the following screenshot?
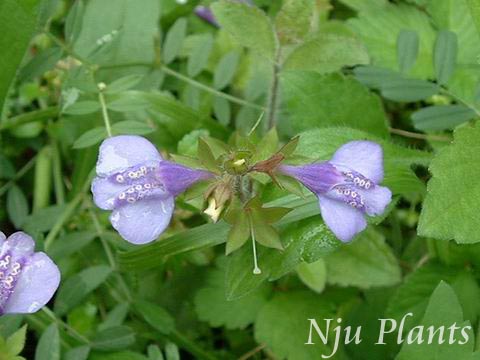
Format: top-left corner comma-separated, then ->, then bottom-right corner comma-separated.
92,135 -> 213,244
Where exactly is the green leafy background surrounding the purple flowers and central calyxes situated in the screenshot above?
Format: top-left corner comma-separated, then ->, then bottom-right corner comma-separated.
0,0 -> 480,360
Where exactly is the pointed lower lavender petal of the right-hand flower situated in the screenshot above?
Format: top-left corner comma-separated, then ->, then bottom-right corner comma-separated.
318,196 -> 367,242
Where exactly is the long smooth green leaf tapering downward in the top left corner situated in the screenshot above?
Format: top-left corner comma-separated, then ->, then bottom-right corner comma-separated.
0,0 -> 39,119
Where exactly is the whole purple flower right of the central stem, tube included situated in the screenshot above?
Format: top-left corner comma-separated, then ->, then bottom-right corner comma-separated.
279,141 -> 392,242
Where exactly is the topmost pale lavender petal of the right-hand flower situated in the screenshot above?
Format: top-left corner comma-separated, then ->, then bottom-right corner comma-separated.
330,141 -> 383,184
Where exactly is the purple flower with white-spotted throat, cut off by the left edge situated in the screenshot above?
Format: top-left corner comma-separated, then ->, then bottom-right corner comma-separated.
0,231 -> 60,315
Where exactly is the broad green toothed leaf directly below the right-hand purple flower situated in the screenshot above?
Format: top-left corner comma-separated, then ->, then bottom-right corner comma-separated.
325,229 -> 401,289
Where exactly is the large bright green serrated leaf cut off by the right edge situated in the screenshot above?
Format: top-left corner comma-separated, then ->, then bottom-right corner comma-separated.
418,125 -> 480,244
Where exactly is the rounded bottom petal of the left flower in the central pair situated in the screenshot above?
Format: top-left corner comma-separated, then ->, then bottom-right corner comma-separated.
110,196 -> 174,244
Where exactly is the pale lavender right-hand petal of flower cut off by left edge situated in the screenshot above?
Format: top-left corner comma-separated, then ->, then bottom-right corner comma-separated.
4,252 -> 60,314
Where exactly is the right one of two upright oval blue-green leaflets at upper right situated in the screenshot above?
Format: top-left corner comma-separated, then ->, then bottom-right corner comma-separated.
433,30 -> 458,85
